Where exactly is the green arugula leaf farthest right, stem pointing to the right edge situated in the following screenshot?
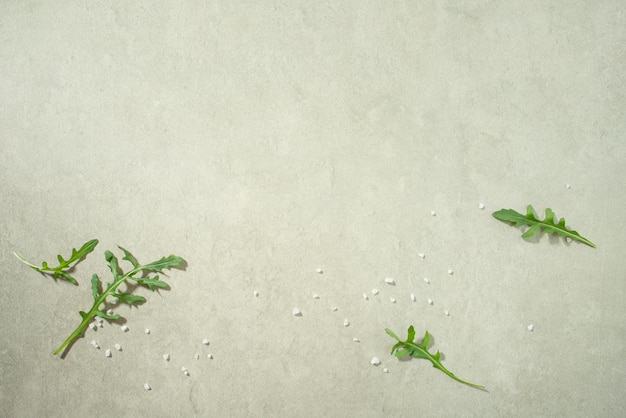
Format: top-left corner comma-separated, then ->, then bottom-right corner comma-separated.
492,205 -> 595,248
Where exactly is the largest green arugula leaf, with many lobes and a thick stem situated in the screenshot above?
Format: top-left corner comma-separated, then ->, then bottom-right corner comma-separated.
54,246 -> 184,354
